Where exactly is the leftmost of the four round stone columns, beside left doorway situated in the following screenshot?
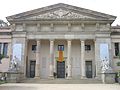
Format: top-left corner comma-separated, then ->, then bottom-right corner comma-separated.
35,40 -> 40,78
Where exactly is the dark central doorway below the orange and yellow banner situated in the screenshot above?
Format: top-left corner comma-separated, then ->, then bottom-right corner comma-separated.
57,61 -> 65,78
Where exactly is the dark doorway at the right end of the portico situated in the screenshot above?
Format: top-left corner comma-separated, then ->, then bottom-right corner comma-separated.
86,61 -> 92,78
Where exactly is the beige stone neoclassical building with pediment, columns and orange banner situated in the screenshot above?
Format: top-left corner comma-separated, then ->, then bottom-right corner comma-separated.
0,3 -> 120,79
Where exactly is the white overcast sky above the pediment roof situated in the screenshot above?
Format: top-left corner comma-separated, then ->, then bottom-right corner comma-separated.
0,0 -> 120,25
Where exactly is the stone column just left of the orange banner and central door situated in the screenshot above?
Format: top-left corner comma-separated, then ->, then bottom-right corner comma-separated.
49,40 -> 54,79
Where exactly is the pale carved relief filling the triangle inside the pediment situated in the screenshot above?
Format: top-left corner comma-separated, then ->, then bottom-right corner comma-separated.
28,9 -> 95,19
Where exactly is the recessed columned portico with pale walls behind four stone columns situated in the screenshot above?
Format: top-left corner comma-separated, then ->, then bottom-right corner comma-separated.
27,39 -> 96,79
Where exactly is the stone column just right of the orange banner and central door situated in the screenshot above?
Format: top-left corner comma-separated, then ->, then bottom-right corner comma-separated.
67,40 -> 72,79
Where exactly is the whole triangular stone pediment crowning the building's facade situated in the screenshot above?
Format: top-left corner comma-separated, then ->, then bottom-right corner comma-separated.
7,3 -> 116,21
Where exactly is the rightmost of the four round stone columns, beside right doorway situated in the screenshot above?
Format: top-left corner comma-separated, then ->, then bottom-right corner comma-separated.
81,40 -> 86,79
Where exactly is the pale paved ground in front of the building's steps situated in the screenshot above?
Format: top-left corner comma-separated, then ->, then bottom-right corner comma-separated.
0,83 -> 120,90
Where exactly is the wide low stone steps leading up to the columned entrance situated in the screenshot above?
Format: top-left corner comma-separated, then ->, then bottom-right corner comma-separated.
22,78 -> 102,84
